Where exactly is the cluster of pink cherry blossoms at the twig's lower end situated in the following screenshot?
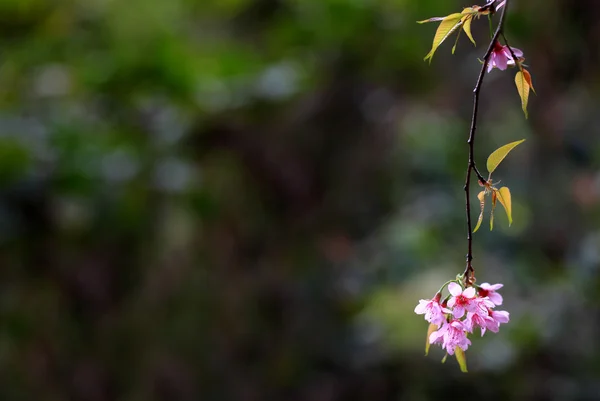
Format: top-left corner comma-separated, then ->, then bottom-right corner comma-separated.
415,281 -> 509,355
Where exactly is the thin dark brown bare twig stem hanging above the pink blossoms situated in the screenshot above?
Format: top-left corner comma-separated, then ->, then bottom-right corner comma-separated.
463,0 -> 509,286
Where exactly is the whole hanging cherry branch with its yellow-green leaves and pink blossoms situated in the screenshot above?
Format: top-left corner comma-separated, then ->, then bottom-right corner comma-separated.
415,0 -> 535,372
